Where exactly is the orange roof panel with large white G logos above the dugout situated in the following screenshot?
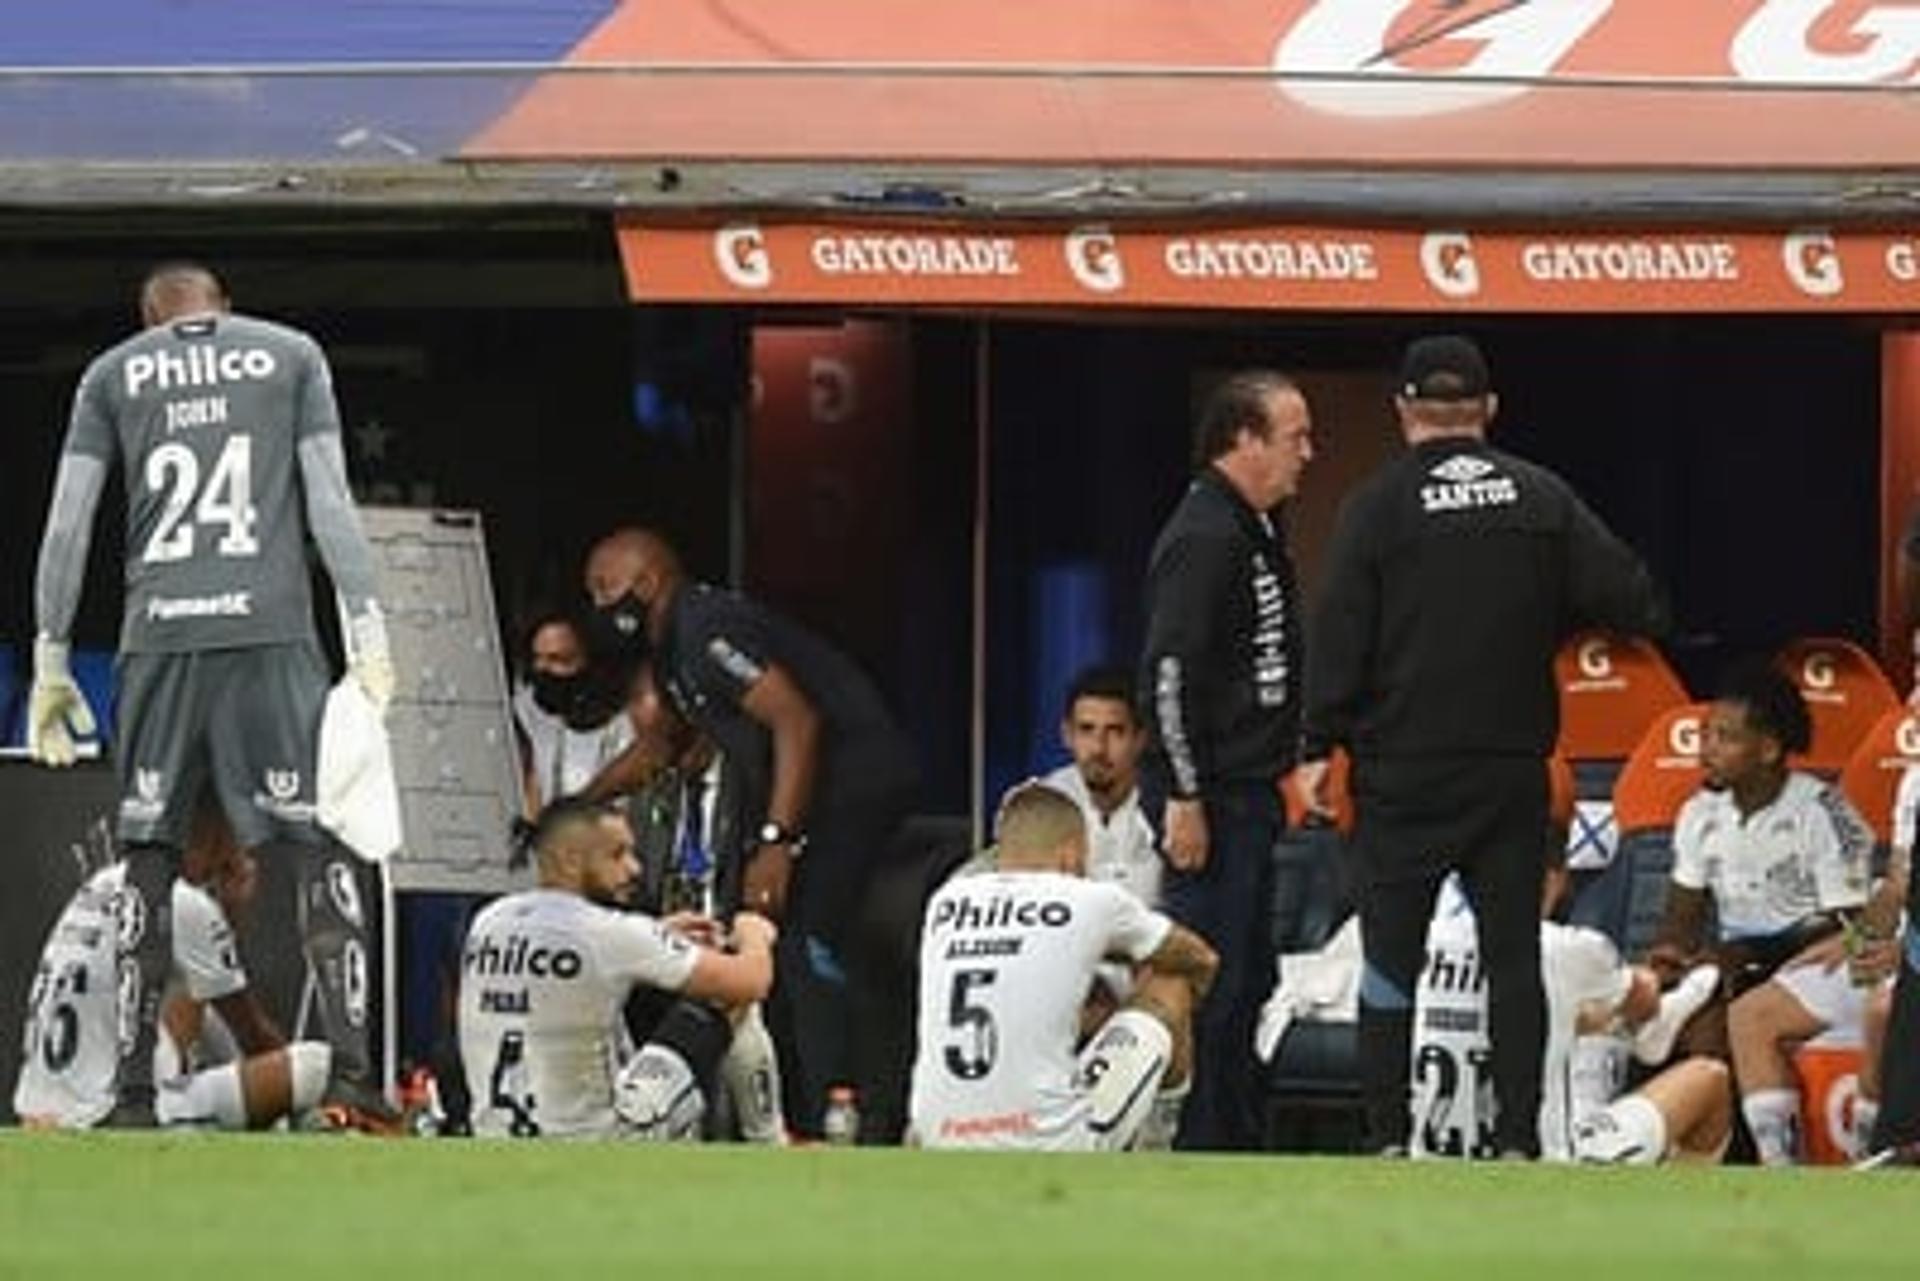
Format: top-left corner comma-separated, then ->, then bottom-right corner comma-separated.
465,0 -> 1920,171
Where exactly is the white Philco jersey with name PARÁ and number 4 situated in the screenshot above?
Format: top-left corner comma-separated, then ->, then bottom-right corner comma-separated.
459,889 -> 697,1137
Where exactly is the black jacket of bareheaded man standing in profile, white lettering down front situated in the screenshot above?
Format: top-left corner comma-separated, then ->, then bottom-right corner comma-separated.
1140,467 -> 1302,797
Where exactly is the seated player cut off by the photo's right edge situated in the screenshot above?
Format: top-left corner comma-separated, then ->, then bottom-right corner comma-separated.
1726,768 -> 1920,1166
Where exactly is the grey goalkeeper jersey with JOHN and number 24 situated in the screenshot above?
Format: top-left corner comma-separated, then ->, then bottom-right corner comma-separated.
65,315 -> 340,653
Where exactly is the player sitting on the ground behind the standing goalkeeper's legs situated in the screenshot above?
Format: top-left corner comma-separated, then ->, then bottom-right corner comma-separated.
13,793 -> 332,1129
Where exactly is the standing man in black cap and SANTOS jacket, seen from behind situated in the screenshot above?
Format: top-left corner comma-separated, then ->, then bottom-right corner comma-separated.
1304,338 -> 1665,1154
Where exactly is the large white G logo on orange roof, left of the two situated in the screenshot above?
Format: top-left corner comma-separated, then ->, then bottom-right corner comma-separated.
1273,0 -> 1613,117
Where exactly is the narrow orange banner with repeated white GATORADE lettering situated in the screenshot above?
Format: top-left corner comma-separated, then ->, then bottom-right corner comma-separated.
618,219 -> 1920,313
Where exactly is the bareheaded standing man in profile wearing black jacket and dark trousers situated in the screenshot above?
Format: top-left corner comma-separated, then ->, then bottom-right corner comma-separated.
1140,371 -> 1313,1150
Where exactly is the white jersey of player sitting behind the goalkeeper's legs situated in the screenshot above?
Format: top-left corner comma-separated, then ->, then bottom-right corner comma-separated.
13,862 -> 246,1129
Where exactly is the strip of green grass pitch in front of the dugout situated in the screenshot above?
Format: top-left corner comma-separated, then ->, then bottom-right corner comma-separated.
0,1133 -> 1920,1281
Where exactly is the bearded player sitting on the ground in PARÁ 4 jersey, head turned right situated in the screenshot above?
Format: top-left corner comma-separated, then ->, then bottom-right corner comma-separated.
459,797 -> 774,1139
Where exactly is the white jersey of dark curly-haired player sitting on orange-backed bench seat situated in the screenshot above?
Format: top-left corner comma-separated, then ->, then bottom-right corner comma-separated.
1672,772 -> 1874,939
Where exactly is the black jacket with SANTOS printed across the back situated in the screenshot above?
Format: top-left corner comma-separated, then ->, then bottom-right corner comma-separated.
1306,436 -> 1667,759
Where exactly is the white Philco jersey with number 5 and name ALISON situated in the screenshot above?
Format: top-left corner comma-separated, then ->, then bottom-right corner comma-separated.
908,872 -> 1173,1148
